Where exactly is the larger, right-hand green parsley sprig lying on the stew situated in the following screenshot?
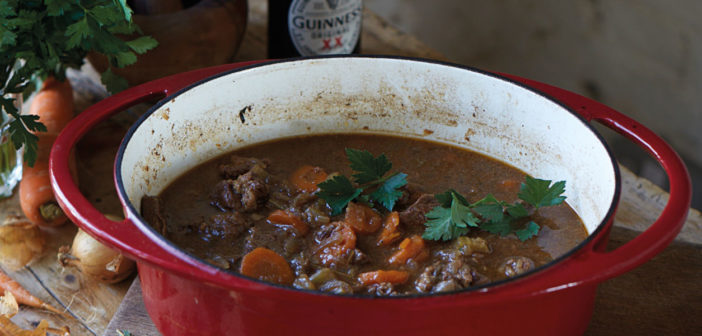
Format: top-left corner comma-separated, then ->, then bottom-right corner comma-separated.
422,176 -> 565,241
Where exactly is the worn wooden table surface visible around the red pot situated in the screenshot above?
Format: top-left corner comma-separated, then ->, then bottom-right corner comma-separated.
0,0 -> 702,336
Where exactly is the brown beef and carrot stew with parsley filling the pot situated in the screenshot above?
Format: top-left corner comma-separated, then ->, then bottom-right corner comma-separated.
142,134 -> 587,296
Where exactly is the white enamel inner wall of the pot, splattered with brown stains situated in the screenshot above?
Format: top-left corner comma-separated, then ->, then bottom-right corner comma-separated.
118,57 -> 615,232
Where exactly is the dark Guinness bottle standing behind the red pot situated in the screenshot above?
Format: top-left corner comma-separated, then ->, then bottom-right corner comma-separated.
268,0 -> 363,58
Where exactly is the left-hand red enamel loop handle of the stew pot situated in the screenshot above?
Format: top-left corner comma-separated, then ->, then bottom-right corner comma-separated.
49,61 -> 261,274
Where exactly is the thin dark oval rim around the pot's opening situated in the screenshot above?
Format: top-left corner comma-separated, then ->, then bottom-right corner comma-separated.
114,55 -> 621,300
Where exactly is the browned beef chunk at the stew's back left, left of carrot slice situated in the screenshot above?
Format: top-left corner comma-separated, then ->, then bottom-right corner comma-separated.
210,165 -> 268,212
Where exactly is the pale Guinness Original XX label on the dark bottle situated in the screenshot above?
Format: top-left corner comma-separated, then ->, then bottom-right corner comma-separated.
288,0 -> 363,56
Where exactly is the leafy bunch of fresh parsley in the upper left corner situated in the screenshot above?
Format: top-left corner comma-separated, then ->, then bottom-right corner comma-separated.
0,0 -> 157,166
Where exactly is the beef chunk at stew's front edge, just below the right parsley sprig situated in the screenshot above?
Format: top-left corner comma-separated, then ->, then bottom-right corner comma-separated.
414,250 -> 478,293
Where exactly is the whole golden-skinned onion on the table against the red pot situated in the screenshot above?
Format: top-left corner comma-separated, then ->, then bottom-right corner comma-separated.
58,229 -> 135,283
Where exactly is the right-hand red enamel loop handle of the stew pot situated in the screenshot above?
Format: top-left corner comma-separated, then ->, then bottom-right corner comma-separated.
500,74 -> 692,287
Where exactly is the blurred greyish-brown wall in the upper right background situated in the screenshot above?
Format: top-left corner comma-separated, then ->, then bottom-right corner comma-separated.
364,0 -> 702,172
